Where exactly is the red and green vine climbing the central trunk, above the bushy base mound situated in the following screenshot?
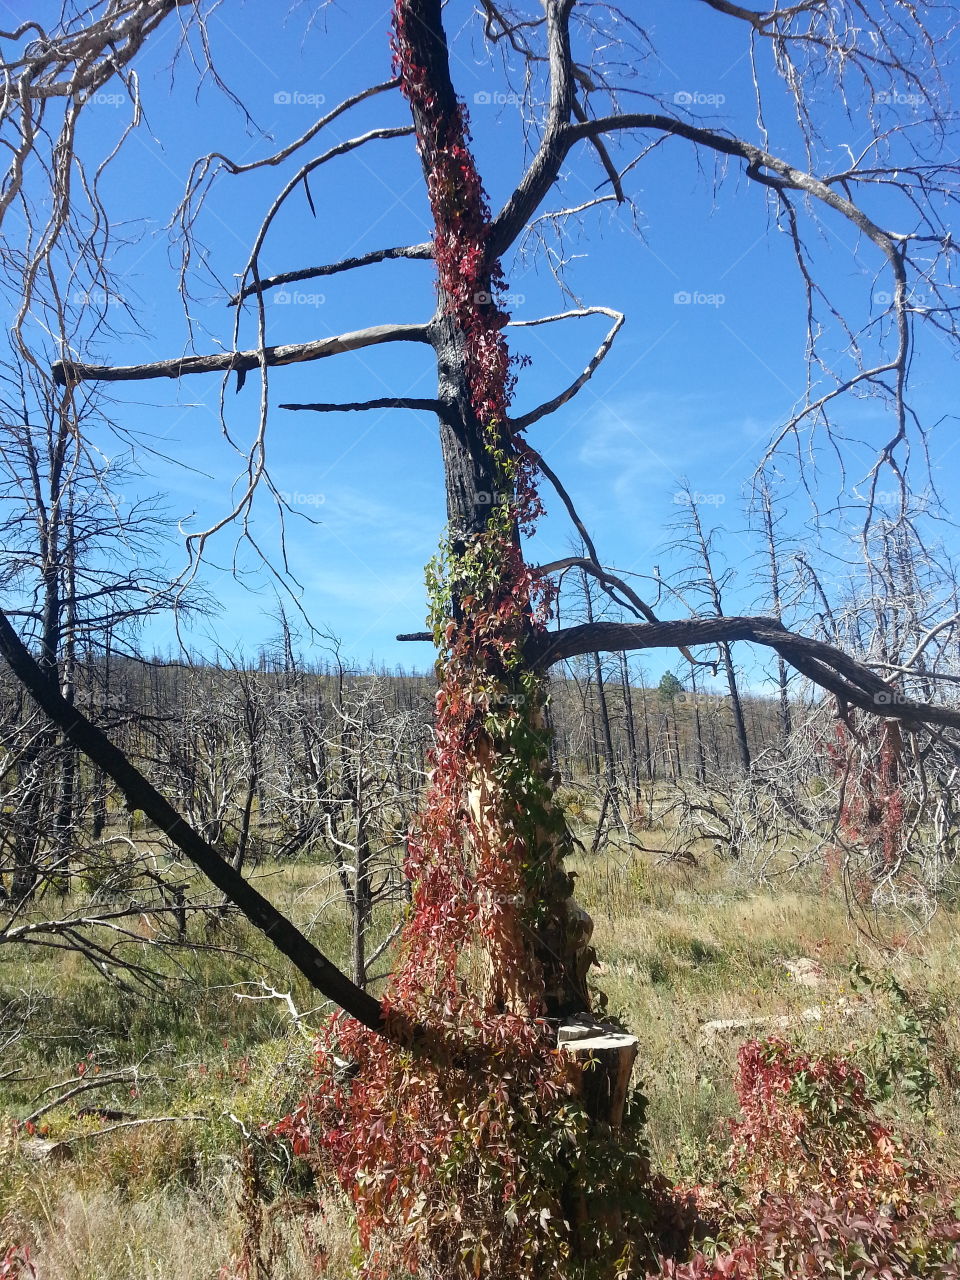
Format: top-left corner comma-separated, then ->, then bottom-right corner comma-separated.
393,3 -> 576,1018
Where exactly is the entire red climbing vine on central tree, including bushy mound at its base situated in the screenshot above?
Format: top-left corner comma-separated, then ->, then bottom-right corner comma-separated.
272,0 -> 669,1280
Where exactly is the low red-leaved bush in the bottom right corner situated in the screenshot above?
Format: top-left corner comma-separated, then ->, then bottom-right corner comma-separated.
650,1038 -> 960,1280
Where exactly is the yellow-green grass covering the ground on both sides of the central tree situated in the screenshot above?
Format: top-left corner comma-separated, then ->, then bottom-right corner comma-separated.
0,833 -> 960,1280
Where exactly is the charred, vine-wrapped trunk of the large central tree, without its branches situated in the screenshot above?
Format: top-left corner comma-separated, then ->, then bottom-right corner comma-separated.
396,0 -> 599,1016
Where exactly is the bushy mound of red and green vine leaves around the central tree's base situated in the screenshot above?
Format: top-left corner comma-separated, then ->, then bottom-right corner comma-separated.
273,1010 -> 684,1280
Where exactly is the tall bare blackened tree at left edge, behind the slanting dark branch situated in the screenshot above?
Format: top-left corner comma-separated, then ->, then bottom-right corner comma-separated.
0,355 -> 196,901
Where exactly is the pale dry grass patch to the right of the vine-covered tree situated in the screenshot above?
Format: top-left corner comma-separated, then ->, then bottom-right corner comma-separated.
577,835 -> 960,1179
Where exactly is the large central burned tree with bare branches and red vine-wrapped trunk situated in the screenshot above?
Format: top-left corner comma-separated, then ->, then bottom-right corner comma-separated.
0,0 -> 960,1252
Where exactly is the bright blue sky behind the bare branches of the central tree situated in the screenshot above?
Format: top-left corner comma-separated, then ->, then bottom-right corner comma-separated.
9,0 -> 960,678
